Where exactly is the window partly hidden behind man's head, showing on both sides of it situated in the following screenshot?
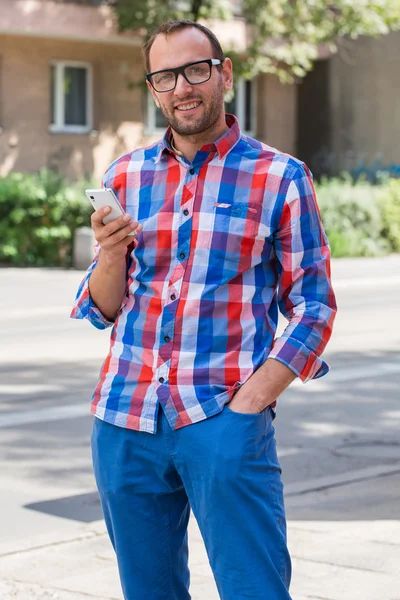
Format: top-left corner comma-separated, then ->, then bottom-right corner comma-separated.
144,79 -> 256,135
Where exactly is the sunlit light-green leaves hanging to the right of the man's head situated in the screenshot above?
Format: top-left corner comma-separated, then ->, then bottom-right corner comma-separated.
243,0 -> 400,82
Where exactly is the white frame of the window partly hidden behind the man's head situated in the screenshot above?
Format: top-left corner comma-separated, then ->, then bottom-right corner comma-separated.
143,77 -> 257,137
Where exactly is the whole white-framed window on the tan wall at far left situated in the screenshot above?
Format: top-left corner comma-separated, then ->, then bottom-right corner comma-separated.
50,61 -> 92,133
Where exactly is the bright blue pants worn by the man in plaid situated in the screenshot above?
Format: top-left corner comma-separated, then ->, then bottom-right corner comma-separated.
92,406 -> 291,600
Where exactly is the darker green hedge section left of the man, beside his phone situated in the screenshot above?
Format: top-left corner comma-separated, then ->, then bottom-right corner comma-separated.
0,170 -> 92,267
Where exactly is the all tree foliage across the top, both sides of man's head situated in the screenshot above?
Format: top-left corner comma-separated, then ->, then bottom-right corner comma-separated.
108,0 -> 400,82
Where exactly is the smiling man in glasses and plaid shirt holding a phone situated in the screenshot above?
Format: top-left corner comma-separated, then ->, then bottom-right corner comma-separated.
72,21 -> 336,600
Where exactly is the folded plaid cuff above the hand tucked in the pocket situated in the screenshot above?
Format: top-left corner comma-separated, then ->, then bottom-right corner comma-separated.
268,337 -> 330,383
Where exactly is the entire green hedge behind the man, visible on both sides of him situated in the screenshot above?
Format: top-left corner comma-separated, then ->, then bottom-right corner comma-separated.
0,170 -> 400,267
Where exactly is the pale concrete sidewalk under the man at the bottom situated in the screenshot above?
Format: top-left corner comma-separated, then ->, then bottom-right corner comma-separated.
0,472 -> 400,600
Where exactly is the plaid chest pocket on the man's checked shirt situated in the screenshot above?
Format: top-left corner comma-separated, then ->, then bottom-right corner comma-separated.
208,200 -> 261,262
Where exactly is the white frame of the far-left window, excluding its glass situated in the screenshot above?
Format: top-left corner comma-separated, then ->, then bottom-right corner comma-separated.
49,60 -> 93,133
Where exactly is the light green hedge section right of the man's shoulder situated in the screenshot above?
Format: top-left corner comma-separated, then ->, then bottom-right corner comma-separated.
315,175 -> 400,258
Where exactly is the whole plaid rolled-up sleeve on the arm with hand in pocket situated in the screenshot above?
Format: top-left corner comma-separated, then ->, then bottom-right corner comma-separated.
269,164 -> 337,383
